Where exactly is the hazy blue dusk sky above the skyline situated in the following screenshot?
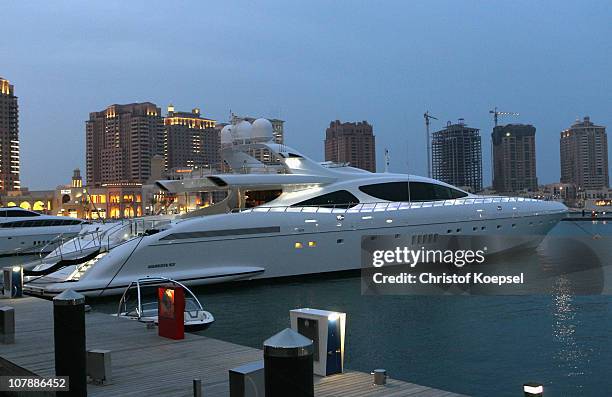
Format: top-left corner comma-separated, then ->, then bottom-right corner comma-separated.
0,0 -> 612,189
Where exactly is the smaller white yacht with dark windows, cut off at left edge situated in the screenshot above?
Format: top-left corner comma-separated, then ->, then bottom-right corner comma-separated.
0,207 -> 89,257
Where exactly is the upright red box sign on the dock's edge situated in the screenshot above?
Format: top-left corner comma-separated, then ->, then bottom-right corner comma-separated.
157,286 -> 185,339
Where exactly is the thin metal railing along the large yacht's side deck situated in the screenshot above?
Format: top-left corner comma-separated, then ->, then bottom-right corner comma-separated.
232,197 -> 539,214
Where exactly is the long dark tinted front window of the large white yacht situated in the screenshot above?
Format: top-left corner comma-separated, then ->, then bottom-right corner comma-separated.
359,182 -> 467,201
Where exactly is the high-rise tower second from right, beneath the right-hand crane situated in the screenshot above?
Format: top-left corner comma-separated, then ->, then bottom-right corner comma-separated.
491,124 -> 538,193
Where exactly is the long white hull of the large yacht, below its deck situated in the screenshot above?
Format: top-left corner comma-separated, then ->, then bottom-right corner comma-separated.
26,198 -> 565,296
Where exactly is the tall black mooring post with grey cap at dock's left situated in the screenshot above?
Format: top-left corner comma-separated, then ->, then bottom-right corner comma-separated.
53,290 -> 87,397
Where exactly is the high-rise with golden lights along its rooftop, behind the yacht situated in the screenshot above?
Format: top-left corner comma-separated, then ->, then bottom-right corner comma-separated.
164,105 -> 221,171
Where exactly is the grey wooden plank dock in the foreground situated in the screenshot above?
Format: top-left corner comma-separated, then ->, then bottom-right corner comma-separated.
0,297 -> 468,397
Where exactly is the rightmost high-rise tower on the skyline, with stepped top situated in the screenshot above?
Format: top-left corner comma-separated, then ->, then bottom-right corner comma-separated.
560,117 -> 609,190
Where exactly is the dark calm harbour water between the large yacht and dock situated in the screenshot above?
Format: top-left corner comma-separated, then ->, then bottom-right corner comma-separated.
94,221 -> 612,397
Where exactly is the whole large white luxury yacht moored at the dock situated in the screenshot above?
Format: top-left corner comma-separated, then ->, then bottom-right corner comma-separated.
26,119 -> 567,296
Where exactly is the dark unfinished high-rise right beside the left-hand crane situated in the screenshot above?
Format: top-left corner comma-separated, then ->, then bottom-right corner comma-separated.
431,119 -> 482,192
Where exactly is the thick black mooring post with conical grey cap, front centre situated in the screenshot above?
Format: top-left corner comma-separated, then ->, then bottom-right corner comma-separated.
264,328 -> 314,397
